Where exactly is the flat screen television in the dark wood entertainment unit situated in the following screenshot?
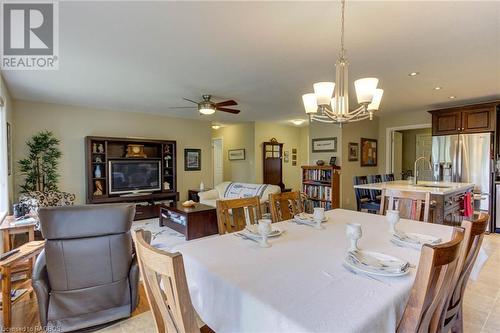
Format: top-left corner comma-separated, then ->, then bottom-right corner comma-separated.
108,160 -> 161,194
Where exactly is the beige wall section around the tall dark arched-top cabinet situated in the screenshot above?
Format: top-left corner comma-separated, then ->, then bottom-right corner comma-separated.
255,122 -> 302,191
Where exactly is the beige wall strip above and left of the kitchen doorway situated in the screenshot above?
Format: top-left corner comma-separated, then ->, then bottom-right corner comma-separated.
378,111 -> 431,173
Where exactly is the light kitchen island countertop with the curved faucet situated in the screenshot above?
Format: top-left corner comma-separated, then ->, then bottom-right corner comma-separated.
354,180 -> 474,195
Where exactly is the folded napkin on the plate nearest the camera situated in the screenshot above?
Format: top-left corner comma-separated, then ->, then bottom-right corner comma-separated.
347,251 -> 410,274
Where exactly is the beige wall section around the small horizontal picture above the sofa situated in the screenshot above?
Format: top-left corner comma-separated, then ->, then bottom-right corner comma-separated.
212,122 -> 256,183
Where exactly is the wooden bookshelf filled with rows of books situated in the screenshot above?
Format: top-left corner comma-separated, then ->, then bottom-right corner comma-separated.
302,165 -> 340,210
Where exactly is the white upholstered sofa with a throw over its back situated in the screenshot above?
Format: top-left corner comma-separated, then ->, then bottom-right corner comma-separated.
198,182 -> 281,207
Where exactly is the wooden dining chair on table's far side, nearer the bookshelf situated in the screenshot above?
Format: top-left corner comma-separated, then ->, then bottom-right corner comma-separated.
269,191 -> 306,222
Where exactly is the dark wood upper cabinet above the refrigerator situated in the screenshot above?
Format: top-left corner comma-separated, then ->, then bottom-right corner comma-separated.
429,101 -> 500,135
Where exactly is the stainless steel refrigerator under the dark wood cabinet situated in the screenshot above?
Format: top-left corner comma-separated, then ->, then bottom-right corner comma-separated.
431,133 -> 494,228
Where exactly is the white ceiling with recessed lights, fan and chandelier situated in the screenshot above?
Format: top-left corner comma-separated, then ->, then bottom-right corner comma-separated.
4,1 -> 500,121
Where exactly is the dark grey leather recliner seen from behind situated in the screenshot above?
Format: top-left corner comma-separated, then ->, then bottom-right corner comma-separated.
33,204 -> 139,332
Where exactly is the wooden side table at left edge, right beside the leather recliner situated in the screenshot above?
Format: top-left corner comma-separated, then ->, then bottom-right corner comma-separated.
0,241 -> 45,332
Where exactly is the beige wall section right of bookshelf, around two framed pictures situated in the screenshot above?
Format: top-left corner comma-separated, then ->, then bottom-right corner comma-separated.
340,117 -> 381,210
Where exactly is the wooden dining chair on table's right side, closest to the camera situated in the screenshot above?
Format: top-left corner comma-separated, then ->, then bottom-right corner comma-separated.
396,227 -> 464,333
